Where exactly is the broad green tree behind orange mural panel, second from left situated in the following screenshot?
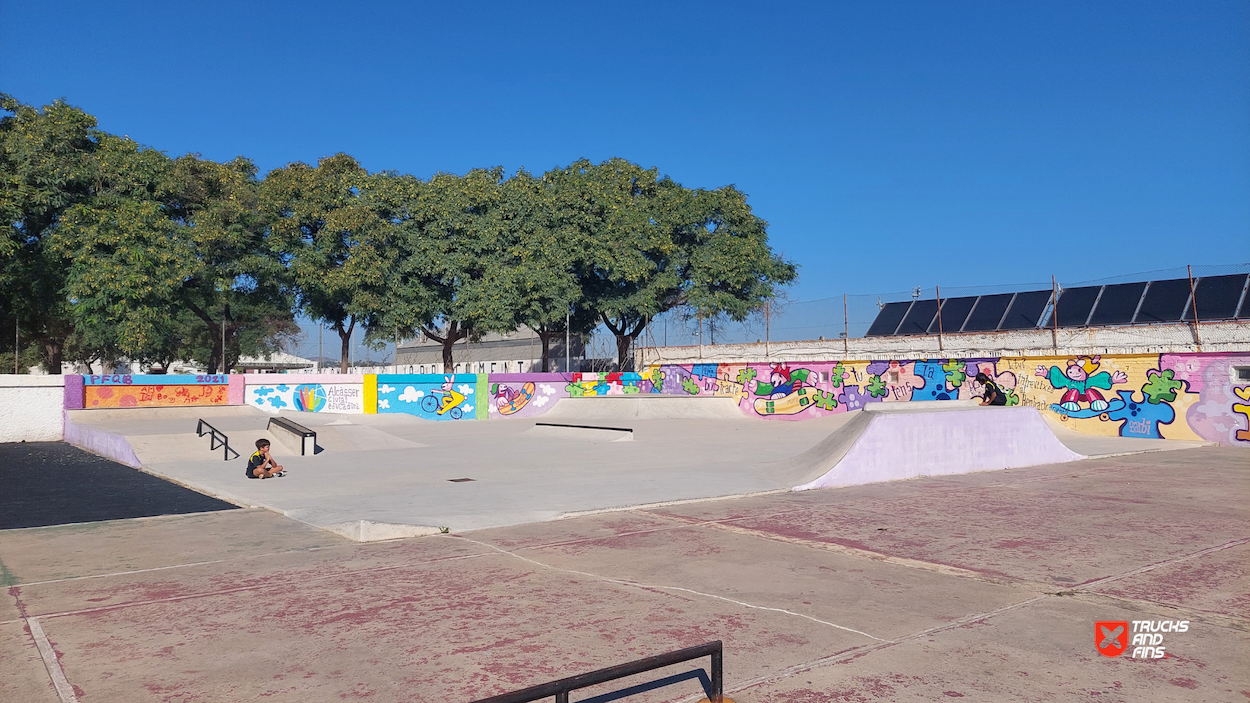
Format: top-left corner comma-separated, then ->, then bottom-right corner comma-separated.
56,145 -> 295,373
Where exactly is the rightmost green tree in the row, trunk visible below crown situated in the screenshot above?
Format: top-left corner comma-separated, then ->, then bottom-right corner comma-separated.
555,159 -> 796,369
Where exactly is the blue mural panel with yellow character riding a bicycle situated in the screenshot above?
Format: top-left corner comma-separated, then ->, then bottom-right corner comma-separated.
378,374 -> 489,420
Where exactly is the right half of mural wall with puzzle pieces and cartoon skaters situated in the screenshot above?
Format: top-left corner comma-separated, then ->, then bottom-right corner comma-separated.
612,354 -> 1250,447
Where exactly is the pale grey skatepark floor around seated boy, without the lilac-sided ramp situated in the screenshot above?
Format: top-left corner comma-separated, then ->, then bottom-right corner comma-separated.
60,398 -> 1210,539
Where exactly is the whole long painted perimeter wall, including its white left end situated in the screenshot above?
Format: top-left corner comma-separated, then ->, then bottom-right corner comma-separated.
0,352 -> 1250,447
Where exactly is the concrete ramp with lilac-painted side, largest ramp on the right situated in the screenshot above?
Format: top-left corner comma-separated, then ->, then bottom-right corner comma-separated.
779,403 -> 1085,490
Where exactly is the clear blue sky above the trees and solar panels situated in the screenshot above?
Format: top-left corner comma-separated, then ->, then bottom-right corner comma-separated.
0,0 -> 1250,299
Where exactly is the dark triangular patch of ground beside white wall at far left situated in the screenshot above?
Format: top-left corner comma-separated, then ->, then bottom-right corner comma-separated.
0,442 -> 243,529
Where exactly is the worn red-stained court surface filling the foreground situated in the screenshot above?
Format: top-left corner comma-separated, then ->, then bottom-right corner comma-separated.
0,448 -> 1250,703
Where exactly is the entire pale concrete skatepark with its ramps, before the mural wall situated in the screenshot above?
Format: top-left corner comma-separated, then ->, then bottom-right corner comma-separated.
60,397 -> 1203,540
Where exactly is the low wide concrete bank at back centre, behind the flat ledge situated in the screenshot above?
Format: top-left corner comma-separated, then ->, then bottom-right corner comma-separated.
543,394 -> 748,423
